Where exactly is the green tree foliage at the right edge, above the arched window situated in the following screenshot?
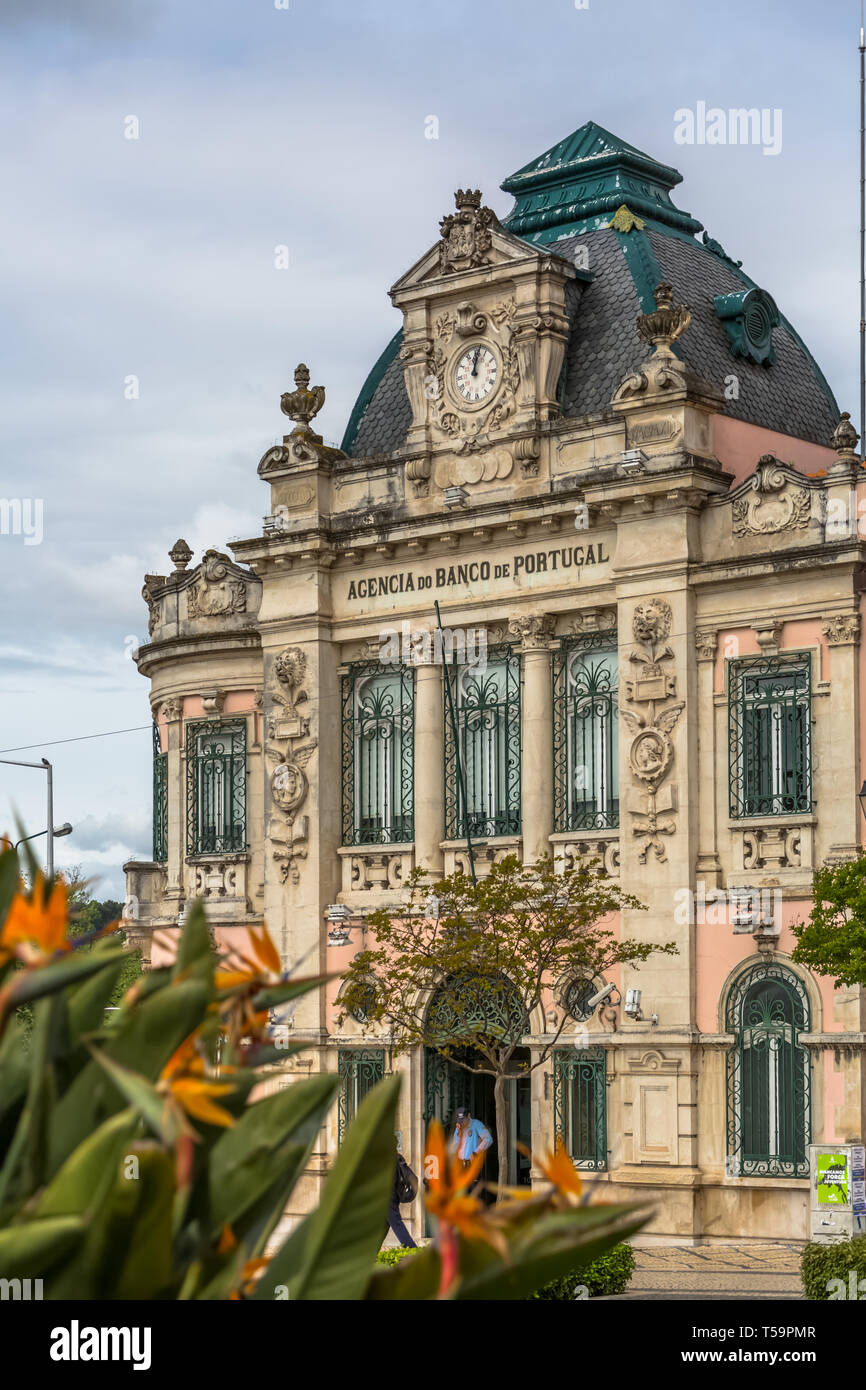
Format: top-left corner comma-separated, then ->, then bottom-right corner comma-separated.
791,855 -> 866,990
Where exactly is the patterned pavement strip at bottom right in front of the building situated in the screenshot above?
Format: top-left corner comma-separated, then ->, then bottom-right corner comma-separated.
605,1243 -> 803,1302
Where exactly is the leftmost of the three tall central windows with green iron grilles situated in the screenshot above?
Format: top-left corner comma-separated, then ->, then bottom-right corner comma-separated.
342,662 -> 414,845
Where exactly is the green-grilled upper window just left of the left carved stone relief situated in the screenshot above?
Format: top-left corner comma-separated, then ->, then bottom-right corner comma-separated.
186,719 -> 246,855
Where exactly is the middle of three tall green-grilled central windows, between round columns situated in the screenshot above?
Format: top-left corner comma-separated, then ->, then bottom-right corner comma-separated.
443,645 -> 520,840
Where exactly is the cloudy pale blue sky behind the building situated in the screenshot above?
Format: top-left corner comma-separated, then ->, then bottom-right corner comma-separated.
0,0 -> 859,895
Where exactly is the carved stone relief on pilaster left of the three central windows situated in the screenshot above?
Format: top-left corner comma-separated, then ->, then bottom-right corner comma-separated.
264,646 -> 318,883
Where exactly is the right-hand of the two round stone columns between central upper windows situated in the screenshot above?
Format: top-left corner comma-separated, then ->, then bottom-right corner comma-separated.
509,613 -> 555,865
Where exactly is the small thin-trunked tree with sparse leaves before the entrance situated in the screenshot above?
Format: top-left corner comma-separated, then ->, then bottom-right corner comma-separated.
339,855 -> 677,1188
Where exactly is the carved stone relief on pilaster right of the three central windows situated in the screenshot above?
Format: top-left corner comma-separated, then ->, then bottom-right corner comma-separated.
620,599 -> 685,863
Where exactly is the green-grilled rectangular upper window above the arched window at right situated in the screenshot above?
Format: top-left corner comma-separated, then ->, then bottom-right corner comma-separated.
728,655 -> 812,817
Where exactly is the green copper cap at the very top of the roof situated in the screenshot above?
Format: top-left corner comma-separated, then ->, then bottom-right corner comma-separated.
502,121 -> 703,243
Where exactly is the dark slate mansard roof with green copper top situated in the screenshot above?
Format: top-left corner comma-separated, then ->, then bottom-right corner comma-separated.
342,121 -> 840,457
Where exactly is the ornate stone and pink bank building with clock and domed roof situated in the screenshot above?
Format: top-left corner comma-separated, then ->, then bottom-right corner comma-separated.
126,122 -> 866,1238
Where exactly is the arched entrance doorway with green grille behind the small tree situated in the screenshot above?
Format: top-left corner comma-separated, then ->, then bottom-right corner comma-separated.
424,977 -> 532,1187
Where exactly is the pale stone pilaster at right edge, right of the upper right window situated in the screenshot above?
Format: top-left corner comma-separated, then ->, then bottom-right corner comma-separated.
812,613 -> 862,859
